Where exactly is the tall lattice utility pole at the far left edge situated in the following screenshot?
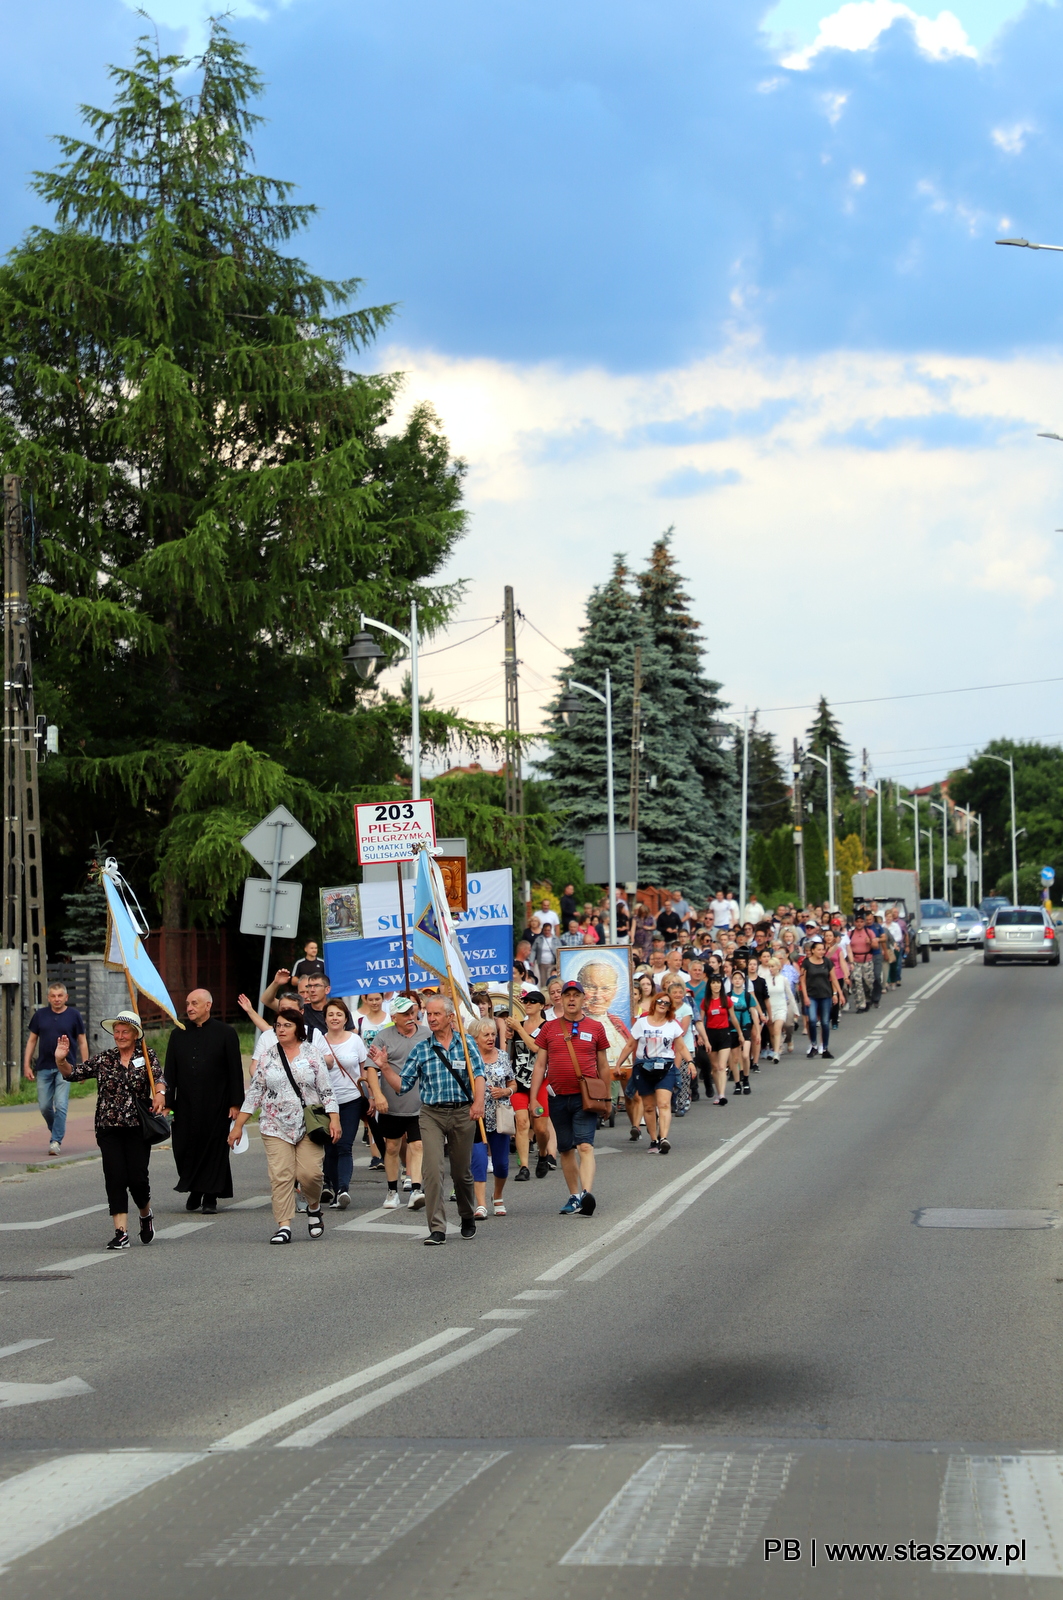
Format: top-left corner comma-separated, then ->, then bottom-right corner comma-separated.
0,474 -> 48,1094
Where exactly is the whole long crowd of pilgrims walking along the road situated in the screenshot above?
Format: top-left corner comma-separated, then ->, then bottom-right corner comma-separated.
49,891 -> 908,1250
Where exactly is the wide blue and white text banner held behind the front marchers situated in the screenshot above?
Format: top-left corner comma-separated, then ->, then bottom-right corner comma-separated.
322,867 -> 512,995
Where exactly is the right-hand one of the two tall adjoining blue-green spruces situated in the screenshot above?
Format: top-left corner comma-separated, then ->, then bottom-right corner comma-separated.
637,528 -> 740,894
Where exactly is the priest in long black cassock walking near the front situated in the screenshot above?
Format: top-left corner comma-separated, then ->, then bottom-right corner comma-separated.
165,989 -> 243,1216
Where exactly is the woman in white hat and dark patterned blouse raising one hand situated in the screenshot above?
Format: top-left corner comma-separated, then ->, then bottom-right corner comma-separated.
56,1011 -> 166,1250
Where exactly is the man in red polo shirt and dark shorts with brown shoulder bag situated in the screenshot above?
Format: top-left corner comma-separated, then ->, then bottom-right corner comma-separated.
532,979 -> 613,1216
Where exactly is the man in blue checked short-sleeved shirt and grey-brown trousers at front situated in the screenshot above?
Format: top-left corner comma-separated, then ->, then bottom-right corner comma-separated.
397,995 -> 485,1245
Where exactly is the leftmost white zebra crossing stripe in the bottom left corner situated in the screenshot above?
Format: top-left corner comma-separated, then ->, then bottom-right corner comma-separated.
0,1451 -> 203,1571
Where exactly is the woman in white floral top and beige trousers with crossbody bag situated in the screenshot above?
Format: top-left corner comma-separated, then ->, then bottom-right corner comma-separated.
229,1011 -> 341,1245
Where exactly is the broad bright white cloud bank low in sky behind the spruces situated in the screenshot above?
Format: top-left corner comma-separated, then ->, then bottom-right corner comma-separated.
376,339 -> 1063,773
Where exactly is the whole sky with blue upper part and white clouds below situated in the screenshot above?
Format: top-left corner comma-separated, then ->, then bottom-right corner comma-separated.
0,0 -> 1063,800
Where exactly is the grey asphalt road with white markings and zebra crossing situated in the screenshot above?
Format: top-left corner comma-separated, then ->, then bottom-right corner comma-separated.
0,954 -> 1063,1600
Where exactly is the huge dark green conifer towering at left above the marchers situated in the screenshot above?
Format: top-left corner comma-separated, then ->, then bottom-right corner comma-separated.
0,22 -> 475,926
